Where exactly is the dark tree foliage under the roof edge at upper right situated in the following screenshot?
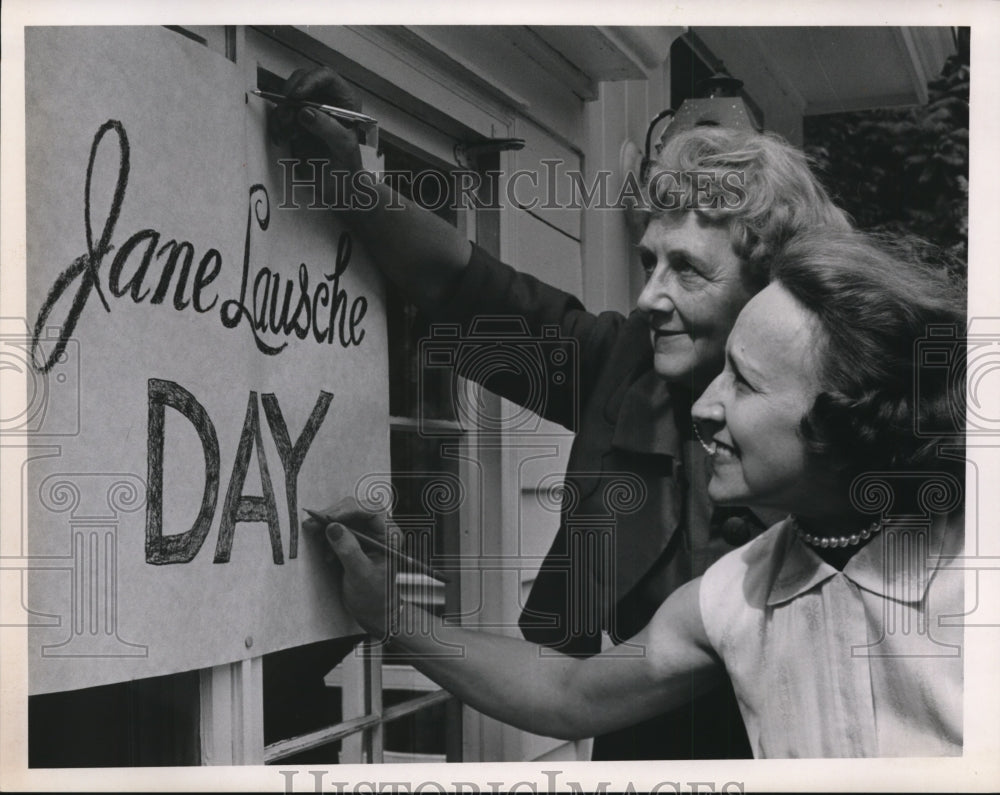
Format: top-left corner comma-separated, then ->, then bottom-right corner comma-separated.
805,28 -> 970,280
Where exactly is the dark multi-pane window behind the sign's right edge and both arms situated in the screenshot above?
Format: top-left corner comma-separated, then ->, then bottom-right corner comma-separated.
263,140 -> 484,764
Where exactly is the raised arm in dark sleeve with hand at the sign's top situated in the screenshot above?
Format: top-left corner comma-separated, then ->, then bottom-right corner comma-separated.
268,68 -> 620,430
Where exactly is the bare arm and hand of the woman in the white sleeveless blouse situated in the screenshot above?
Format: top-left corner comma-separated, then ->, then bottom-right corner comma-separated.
327,524 -> 721,739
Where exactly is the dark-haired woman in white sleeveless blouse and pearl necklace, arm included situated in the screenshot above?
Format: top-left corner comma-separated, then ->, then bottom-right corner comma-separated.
327,232 -> 964,757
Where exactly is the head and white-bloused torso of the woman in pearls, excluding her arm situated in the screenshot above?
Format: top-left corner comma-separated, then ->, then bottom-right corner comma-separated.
693,233 -> 965,756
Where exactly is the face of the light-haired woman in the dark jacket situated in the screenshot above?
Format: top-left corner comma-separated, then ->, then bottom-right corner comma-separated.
638,212 -> 753,394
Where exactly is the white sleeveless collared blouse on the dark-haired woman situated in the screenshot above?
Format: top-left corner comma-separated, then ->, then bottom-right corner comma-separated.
699,516 -> 965,757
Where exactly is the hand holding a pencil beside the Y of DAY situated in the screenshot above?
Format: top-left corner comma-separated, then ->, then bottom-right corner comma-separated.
325,522 -> 399,639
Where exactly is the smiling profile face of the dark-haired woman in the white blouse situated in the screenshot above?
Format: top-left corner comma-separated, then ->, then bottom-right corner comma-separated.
691,283 -> 844,516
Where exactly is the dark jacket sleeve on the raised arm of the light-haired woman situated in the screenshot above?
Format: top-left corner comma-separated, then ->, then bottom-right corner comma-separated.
428,246 -> 625,431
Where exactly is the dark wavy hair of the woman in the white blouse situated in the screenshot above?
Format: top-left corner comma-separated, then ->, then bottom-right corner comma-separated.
772,229 -> 966,478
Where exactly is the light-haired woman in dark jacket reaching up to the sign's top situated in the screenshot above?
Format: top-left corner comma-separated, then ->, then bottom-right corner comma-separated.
271,69 -> 848,759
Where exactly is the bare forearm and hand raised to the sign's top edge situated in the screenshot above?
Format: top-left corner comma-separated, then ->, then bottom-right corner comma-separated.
269,68 -> 472,306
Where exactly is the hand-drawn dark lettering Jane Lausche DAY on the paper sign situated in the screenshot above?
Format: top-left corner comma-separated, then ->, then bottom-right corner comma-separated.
31,120 -> 368,565
